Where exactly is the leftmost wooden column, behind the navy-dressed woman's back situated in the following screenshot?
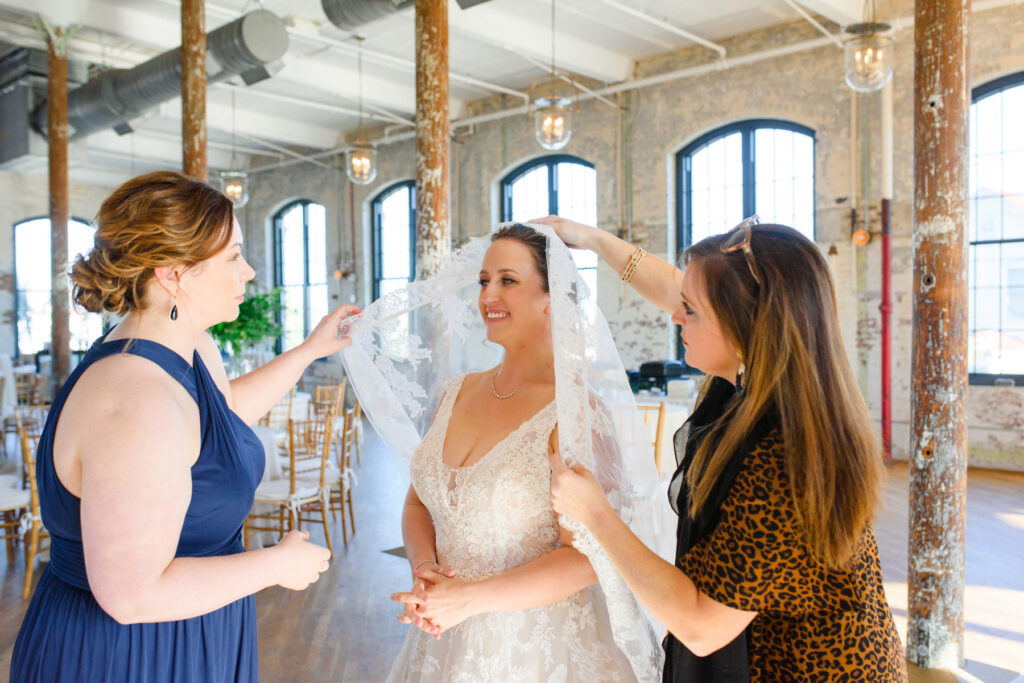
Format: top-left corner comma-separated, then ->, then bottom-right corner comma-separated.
46,26 -> 71,388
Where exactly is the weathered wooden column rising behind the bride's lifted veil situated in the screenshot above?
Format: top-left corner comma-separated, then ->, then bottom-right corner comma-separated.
416,0 -> 452,279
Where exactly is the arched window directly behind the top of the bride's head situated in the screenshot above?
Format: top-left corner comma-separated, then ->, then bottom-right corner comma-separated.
502,155 -> 597,294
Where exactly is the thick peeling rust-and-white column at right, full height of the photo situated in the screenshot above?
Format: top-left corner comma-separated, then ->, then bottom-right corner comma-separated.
906,0 -> 971,668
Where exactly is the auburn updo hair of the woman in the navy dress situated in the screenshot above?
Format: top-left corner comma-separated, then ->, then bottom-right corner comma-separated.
71,171 -> 232,314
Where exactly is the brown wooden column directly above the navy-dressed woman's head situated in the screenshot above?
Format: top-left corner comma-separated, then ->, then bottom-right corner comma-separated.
181,0 -> 207,180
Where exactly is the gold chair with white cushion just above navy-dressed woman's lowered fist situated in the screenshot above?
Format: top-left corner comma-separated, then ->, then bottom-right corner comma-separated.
243,405 -> 334,552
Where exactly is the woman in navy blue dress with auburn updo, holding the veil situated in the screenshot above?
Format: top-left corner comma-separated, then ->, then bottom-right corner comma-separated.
10,171 -> 357,683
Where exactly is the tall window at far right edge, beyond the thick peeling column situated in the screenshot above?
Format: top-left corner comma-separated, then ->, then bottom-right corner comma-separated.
968,72 -> 1024,385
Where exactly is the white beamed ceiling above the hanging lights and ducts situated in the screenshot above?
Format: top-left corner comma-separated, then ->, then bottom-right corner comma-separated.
0,0 -> 862,182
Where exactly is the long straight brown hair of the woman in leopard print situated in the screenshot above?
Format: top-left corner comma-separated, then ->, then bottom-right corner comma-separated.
683,224 -> 884,567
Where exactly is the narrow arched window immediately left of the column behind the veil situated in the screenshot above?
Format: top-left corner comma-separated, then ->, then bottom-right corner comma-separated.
373,180 -> 416,299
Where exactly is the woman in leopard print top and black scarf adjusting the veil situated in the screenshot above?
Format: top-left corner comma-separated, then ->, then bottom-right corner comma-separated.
541,216 -> 906,683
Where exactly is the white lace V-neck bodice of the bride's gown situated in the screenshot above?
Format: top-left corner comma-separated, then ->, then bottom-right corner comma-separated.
411,377 -> 558,581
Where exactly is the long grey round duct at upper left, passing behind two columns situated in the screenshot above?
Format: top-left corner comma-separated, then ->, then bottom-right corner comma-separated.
32,9 -> 288,139
